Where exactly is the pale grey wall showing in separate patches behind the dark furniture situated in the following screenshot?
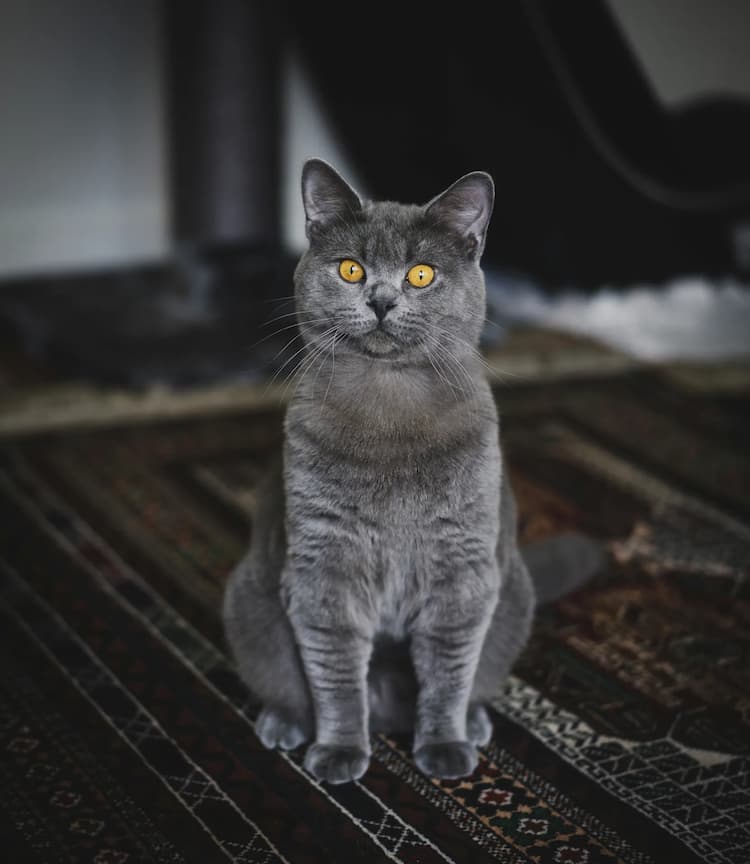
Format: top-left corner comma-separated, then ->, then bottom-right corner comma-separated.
0,0 -> 750,277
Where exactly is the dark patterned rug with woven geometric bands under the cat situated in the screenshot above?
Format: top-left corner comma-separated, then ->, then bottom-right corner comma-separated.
0,352 -> 750,864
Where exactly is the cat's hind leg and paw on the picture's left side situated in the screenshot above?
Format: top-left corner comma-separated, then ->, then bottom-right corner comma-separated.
223,555 -> 314,750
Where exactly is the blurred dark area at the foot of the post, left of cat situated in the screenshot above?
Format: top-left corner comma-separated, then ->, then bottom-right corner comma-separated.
0,255 -> 294,389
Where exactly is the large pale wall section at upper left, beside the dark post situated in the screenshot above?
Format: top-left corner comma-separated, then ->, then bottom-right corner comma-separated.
0,0 -> 168,275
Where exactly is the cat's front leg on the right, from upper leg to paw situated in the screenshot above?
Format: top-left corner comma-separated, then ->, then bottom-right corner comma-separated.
411,575 -> 497,778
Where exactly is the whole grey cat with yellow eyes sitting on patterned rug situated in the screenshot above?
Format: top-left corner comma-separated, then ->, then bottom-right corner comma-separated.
224,159 -> 596,783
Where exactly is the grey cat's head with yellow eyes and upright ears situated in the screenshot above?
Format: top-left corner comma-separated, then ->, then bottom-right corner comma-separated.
295,159 -> 494,368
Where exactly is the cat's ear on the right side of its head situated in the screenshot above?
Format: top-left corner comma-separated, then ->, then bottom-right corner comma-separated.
426,171 -> 495,258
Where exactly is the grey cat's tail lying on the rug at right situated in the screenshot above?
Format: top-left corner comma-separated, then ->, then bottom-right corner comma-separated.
521,531 -> 605,603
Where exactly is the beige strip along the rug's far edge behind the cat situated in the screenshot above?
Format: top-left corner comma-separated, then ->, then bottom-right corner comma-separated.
0,328 -> 750,437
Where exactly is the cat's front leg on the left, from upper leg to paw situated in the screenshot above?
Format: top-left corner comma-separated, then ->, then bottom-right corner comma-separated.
285,550 -> 374,783
